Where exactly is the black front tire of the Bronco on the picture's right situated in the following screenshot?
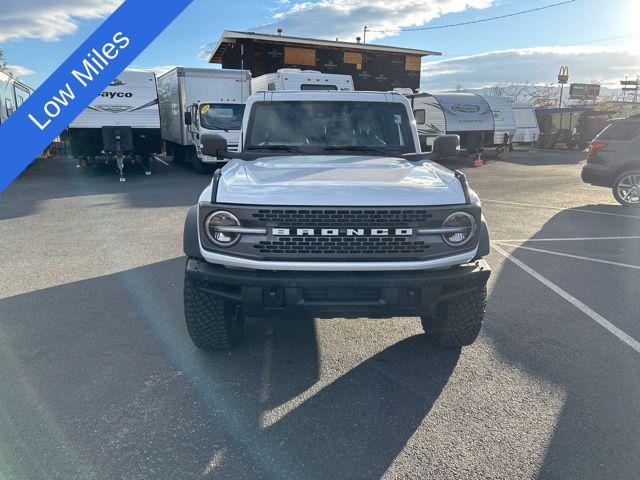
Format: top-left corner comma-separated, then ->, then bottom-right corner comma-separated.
421,287 -> 487,347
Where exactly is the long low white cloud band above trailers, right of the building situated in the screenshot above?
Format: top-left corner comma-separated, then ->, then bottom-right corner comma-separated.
421,46 -> 640,91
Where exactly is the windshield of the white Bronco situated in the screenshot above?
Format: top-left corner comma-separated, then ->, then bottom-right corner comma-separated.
245,101 -> 415,154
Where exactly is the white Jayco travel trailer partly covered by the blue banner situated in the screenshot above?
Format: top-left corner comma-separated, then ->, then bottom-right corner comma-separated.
68,70 -> 162,181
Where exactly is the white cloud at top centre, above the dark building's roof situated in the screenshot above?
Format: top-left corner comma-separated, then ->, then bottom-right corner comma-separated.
255,0 -> 496,41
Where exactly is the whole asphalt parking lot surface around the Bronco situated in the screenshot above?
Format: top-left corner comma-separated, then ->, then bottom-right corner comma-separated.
0,151 -> 640,480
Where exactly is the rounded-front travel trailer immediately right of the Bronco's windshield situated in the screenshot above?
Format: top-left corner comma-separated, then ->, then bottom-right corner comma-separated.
410,93 -> 495,154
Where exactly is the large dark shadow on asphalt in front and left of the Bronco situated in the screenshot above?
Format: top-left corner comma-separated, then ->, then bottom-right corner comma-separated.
0,258 -> 460,479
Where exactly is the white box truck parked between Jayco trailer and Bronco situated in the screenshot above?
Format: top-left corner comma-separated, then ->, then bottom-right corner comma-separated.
158,67 -> 251,173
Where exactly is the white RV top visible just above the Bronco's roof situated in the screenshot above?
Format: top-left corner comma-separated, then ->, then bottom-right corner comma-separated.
251,68 -> 353,92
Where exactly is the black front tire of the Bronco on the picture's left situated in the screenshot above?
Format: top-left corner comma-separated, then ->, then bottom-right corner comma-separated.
184,276 -> 244,350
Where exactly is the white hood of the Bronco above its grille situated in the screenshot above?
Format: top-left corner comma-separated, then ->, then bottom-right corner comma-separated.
216,155 -> 465,206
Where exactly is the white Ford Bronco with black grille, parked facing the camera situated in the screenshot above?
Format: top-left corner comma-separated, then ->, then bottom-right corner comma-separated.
184,91 -> 490,350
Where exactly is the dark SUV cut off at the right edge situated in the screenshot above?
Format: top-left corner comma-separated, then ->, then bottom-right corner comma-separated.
582,115 -> 640,207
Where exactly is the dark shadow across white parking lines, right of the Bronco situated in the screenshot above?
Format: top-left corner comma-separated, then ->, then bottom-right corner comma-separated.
484,207 -> 640,480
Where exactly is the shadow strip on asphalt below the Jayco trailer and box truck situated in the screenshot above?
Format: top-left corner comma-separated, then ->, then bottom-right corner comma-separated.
0,158 -> 211,220
